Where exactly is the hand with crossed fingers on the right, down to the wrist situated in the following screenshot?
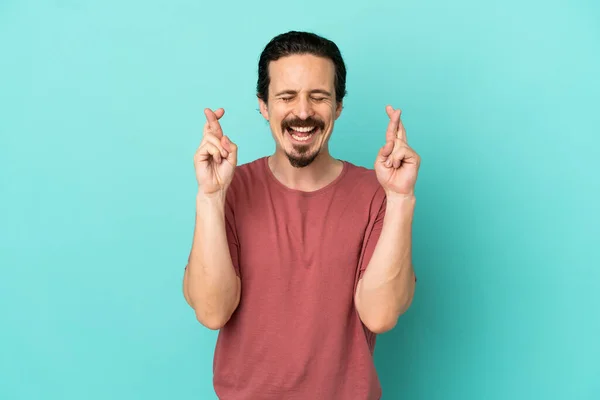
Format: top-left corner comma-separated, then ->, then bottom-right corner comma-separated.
375,106 -> 421,196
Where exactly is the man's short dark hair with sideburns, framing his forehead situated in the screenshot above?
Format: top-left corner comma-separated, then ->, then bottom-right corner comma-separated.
256,31 -> 346,103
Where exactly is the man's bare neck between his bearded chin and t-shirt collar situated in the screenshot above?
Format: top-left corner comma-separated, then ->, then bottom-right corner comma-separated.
268,151 -> 343,192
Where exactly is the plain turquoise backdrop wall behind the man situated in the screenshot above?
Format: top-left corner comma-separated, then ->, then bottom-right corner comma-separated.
0,0 -> 600,400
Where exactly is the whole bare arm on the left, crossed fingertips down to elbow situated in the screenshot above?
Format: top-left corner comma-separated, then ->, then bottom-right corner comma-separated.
183,108 -> 241,329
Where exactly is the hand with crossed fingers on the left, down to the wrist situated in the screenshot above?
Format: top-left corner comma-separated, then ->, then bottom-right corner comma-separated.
194,108 -> 237,196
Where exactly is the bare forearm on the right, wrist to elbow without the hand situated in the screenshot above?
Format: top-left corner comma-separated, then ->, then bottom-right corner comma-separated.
355,196 -> 415,332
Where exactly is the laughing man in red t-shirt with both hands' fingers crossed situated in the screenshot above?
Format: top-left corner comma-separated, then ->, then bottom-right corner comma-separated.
183,32 -> 420,400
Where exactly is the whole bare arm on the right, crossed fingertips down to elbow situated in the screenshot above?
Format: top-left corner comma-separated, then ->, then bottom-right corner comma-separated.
354,106 -> 421,333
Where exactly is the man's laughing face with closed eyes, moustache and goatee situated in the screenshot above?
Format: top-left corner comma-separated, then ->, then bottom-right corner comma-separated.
259,54 -> 342,168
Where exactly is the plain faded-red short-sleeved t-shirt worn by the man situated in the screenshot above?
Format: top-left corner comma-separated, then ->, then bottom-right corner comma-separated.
214,157 -> 386,400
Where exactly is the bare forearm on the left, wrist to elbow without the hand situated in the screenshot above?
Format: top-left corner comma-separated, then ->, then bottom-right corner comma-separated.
184,196 -> 240,329
